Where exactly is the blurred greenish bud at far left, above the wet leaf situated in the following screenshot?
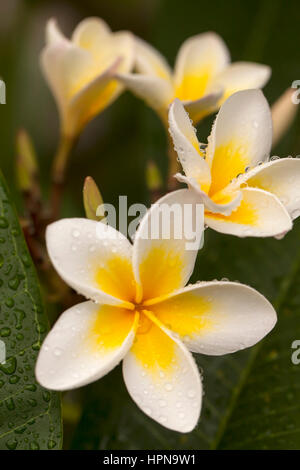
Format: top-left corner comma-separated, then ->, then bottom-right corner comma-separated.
16,129 -> 38,192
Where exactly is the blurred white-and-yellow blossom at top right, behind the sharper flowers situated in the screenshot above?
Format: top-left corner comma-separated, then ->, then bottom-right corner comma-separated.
118,32 -> 271,123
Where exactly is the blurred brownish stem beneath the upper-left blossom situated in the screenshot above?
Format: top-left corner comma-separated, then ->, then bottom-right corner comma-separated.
50,135 -> 75,221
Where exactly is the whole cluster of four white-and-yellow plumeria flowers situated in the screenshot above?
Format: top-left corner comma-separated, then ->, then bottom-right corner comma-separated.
36,18 -> 300,432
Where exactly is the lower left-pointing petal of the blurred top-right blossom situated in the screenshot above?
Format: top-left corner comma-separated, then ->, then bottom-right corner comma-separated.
116,73 -> 173,110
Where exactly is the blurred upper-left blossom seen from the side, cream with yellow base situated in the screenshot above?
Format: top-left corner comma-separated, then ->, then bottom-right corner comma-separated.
41,18 -> 134,137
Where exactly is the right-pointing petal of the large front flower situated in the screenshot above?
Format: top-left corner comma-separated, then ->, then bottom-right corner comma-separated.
147,281 -> 277,355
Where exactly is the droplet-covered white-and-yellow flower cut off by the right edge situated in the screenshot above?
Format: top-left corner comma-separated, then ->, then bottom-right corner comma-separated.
169,90 -> 300,237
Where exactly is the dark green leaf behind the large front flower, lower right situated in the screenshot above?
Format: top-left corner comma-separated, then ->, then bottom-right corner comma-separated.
73,223 -> 300,449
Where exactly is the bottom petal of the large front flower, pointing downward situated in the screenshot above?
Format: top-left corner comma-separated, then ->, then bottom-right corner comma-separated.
123,313 -> 202,433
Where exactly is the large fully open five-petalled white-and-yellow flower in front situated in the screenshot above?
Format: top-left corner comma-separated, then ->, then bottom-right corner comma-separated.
36,189 -> 276,432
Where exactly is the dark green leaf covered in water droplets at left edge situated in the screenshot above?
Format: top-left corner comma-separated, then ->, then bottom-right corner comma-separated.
0,171 -> 62,449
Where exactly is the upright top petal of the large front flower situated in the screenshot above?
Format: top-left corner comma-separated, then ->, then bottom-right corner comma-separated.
132,189 -> 203,302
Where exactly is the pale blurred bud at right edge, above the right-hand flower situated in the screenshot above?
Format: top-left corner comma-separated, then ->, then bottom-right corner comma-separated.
271,88 -> 298,147
